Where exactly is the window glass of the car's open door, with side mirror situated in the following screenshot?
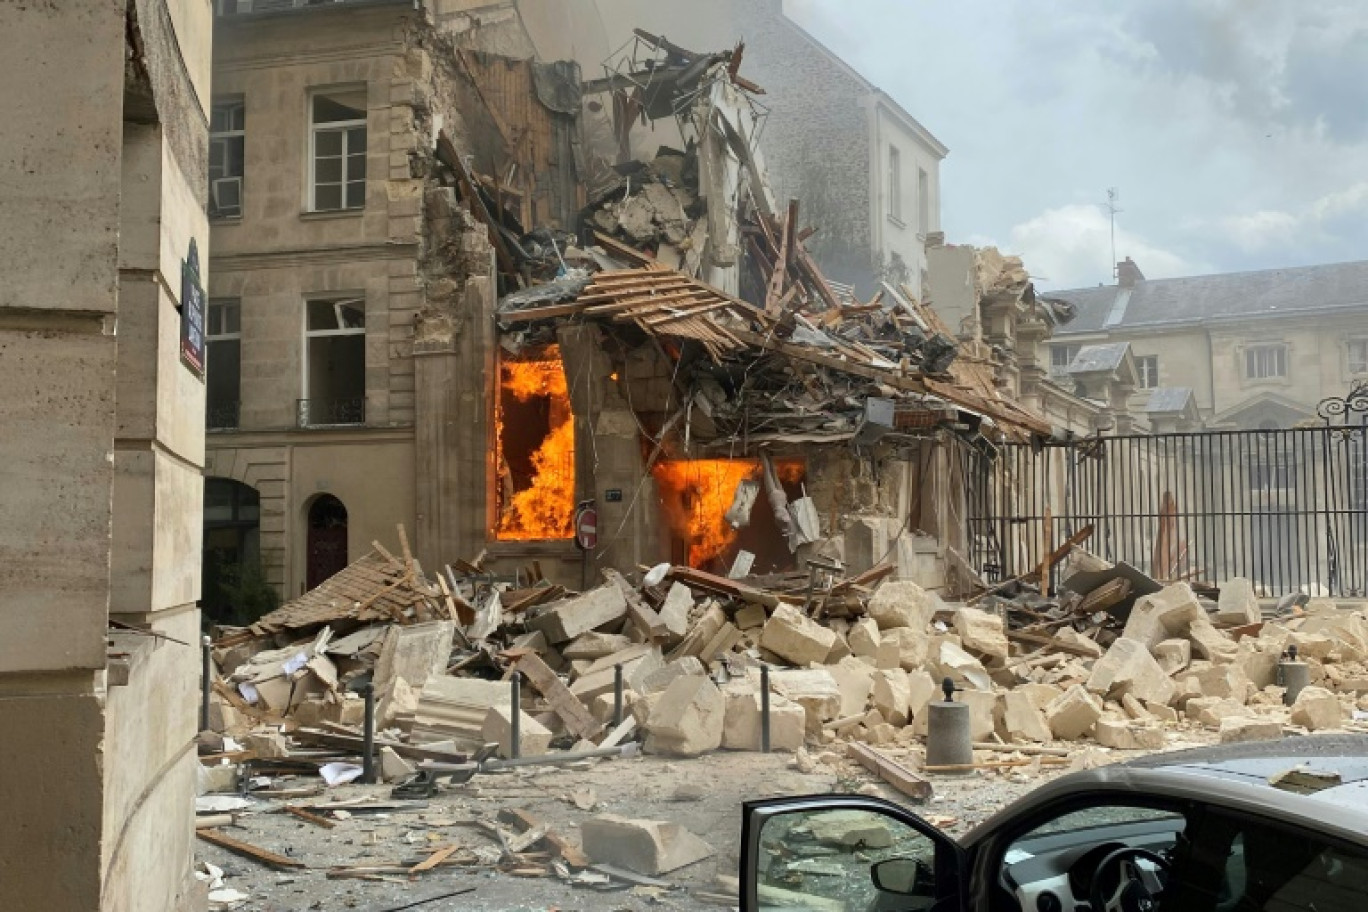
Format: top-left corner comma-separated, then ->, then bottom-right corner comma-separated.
758,809 -> 937,912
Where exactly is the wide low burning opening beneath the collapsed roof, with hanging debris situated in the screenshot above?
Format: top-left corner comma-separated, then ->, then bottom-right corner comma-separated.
651,459 -> 806,573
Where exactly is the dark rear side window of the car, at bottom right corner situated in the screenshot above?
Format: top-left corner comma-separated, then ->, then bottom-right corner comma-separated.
1190,820 -> 1368,912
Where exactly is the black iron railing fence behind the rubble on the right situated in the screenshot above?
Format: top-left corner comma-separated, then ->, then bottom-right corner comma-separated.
964,425 -> 1368,596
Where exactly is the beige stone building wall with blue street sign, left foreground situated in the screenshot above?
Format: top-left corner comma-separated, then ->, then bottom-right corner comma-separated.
0,0 -> 212,912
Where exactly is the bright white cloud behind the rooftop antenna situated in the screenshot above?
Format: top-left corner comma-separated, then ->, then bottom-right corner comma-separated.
1011,205 -> 1208,289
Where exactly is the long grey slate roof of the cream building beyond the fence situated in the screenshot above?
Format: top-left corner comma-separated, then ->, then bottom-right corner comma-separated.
1040,260 -> 1368,338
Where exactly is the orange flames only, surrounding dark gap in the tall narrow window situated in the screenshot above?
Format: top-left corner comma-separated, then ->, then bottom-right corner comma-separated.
495,345 -> 575,541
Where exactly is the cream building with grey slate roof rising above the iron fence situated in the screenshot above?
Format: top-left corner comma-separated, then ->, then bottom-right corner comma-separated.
1041,258 -> 1368,431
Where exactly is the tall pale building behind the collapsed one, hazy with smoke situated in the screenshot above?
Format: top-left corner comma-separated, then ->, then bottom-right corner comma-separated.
517,0 -> 948,299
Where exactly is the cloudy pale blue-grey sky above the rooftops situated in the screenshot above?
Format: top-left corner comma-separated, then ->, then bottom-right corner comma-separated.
785,0 -> 1368,289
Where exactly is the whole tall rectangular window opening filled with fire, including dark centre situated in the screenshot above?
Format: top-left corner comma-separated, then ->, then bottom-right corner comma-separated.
494,345 -> 575,541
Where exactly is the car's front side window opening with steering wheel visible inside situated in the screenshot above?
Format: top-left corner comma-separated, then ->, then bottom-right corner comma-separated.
1000,803 -> 1187,911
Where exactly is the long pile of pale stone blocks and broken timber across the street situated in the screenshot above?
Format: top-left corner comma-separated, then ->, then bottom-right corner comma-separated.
199,530 -> 1368,793
